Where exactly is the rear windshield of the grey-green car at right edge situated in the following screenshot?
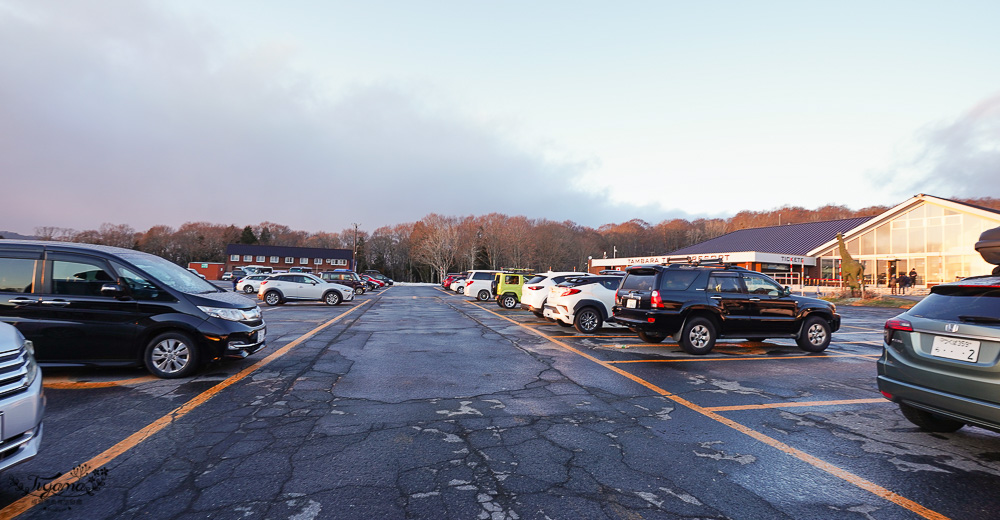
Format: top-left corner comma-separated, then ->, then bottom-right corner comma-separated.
908,286 -> 1000,321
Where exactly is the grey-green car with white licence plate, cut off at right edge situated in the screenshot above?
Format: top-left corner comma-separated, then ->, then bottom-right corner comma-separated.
877,274 -> 1000,432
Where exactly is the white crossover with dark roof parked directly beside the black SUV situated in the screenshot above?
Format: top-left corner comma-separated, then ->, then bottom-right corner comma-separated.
542,275 -> 622,334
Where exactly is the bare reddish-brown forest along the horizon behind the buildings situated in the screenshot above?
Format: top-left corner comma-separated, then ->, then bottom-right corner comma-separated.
9,197 -> 1000,282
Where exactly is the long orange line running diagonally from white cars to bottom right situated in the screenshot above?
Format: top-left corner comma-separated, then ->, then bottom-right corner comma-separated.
464,302 -> 948,520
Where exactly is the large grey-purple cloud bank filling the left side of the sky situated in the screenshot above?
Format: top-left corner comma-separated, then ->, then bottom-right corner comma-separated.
0,0 -> 688,233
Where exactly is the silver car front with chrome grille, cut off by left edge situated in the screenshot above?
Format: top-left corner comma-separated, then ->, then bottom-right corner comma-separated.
0,322 -> 45,470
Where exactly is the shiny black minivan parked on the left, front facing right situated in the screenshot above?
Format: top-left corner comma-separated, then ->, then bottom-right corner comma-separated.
0,240 -> 266,378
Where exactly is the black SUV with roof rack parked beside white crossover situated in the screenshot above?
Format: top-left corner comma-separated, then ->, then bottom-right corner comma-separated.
612,263 -> 840,355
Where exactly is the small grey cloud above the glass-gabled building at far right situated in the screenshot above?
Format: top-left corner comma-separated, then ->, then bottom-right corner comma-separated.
906,94 -> 1000,198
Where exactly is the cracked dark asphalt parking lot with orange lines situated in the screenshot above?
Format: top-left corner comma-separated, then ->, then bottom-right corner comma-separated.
0,286 -> 1000,519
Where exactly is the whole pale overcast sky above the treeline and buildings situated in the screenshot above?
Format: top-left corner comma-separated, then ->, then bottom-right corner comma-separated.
0,0 -> 1000,234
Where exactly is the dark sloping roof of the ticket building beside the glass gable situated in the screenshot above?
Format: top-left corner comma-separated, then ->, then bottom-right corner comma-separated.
670,217 -> 875,255
